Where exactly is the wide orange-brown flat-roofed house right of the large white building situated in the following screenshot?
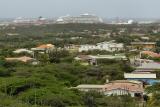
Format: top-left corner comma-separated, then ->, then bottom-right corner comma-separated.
131,42 -> 156,50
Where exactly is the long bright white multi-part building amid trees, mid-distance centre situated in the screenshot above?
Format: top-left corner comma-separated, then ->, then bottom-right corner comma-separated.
79,41 -> 124,52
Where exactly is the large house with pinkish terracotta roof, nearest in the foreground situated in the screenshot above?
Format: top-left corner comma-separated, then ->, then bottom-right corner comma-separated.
104,80 -> 144,97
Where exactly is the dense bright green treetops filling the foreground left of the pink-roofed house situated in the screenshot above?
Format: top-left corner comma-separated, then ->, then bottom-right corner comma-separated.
0,55 -> 134,107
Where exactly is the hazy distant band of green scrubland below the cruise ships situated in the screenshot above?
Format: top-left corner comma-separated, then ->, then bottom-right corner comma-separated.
0,24 -> 159,48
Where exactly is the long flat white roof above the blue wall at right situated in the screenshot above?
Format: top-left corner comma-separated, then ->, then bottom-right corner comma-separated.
124,73 -> 156,79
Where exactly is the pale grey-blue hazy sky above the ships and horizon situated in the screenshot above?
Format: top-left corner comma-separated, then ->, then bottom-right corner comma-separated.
0,0 -> 160,18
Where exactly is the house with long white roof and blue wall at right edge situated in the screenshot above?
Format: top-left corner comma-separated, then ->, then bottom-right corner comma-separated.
124,72 -> 160,85
